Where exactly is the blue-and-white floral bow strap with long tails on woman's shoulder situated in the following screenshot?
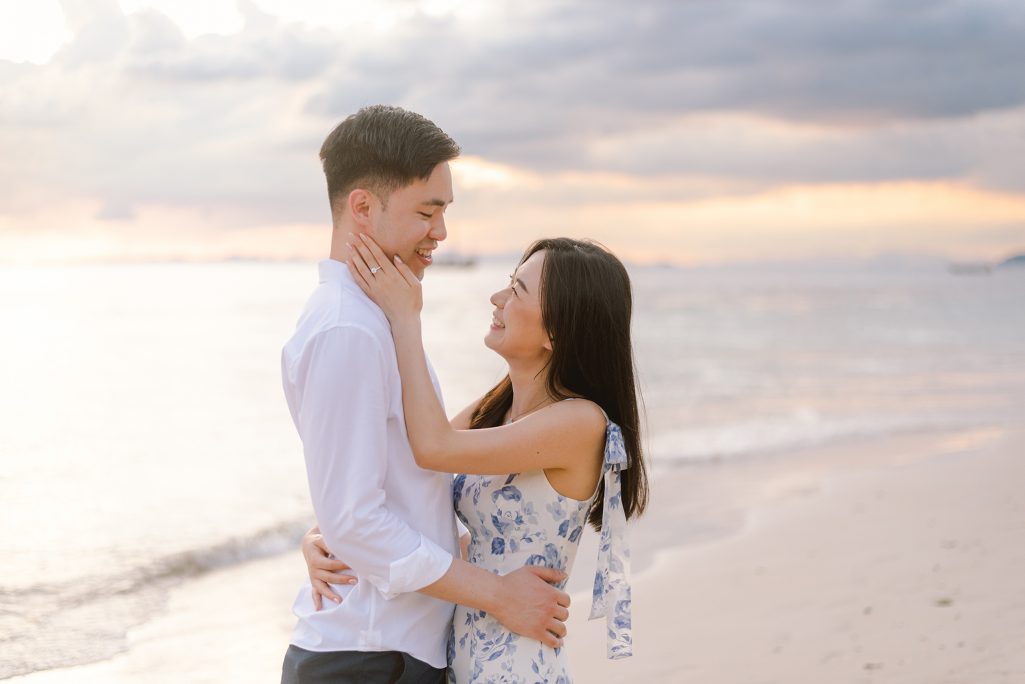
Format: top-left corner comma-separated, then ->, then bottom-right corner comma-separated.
588,416 -> 633,660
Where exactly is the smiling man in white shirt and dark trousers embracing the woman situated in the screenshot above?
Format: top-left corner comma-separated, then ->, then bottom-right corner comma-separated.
282,106 -> 569,684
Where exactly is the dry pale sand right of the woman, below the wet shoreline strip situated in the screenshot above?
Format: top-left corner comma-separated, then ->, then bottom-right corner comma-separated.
571,431 -> 1025,684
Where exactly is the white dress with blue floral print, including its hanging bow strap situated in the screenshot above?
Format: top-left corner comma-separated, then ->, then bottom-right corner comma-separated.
448,420 -> 632,684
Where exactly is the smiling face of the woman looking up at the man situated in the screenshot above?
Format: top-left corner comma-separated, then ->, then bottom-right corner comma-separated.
484,250 -> 551,361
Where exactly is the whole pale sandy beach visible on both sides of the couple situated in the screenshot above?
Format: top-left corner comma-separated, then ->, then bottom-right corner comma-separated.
8,428 -> 1025,684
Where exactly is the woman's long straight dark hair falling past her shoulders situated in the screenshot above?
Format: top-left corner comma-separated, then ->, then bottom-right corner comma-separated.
469,238 -> 648,529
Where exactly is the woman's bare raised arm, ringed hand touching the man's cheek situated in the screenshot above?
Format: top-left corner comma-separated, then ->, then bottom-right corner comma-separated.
349,235 -> 605,475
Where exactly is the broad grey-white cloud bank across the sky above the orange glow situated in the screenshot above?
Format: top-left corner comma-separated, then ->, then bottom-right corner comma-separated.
0,0 -> 1025,266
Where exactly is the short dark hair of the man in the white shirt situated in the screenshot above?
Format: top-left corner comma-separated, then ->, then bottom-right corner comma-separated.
320,105 -> 459,210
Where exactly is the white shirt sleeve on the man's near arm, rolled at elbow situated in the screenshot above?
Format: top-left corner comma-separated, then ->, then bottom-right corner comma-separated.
298,326 -> 452,598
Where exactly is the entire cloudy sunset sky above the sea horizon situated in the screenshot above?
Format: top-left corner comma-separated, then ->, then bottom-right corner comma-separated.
0,0 -> 1025,265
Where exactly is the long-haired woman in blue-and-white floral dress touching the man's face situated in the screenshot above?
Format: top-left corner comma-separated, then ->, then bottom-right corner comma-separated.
306,236 -> 648,682
